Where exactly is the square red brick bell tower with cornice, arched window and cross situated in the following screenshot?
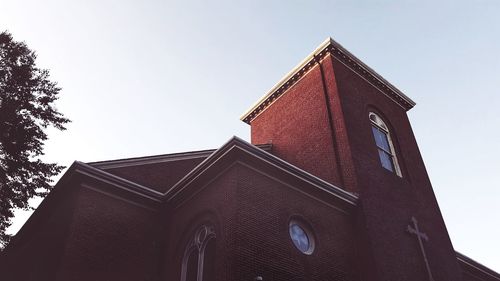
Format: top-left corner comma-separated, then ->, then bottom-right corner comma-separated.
241,38 -> 461,281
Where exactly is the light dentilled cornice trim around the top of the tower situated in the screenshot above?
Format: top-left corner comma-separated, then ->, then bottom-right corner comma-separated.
240,37 -> 415,124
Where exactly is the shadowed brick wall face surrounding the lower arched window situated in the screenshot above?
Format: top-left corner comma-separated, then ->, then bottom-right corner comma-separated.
161,164 -> 237,281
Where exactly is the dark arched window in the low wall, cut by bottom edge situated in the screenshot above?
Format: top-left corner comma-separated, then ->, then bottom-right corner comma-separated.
181,225 -> 215,281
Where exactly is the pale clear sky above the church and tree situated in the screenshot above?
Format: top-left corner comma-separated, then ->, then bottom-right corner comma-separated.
0,0 -> 500,272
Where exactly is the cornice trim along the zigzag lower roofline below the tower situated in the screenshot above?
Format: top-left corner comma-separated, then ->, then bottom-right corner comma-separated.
3,137 -> 352,253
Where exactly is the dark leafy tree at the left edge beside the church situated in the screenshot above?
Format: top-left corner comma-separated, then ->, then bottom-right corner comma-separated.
0,31 -> 69,246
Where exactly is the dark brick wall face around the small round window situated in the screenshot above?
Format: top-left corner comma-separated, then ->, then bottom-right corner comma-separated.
234,163 -> 358,281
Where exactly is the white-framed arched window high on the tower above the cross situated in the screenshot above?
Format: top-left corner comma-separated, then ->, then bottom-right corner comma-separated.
368,112 -> 402,177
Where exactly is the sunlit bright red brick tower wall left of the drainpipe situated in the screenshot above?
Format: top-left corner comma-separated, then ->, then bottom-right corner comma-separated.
251,63 -> 342,186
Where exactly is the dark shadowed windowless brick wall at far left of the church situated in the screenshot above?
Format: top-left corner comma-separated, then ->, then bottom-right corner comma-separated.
0,176 -> 159,281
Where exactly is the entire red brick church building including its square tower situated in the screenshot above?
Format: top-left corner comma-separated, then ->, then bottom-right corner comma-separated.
0,39 -> 500,281
